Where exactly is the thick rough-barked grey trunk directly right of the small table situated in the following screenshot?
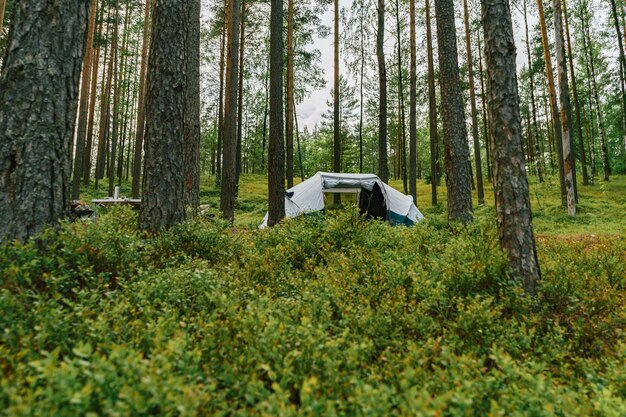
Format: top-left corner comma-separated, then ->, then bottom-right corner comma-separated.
138,0 -> 190,232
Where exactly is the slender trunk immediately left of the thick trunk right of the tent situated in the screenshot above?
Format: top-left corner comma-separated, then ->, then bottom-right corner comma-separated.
425,0 -> 441,206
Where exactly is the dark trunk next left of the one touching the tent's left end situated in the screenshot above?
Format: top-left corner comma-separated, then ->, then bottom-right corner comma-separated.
220,0 -> 241,223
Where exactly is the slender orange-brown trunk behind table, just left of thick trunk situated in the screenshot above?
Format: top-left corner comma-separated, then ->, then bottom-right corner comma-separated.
132,0 -> 154,198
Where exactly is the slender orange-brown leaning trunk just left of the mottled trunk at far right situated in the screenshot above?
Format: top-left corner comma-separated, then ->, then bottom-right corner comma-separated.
537,0 -> 567,207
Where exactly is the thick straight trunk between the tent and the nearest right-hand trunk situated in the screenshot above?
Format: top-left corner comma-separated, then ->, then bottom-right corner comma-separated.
435,0 -> 472,223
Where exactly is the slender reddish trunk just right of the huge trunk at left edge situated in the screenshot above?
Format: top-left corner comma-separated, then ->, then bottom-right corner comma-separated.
71,0 -> 98,200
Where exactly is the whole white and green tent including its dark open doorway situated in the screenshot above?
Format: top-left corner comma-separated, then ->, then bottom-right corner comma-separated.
260,172 -> 424,227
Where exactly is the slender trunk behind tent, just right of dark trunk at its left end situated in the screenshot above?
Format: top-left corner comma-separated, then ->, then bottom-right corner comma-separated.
285,0 -> 295,188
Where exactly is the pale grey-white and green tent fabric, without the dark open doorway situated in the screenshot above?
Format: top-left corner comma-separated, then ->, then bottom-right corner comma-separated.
260,172 -> 424,228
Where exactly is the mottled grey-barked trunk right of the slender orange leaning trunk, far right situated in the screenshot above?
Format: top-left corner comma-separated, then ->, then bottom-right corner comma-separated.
553,0 -> 576,216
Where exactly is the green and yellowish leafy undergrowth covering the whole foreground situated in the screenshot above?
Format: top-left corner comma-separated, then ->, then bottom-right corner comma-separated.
0,208 -> 626,416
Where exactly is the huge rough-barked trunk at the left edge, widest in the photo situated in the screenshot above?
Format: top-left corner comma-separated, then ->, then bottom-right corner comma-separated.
0,0 -> 90,242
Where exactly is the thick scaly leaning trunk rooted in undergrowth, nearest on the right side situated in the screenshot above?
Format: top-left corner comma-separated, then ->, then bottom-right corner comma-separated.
482,0 -> 540,294
